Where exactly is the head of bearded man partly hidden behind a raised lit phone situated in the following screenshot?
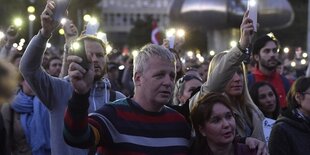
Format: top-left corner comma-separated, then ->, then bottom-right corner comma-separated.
69,35 -> 107,81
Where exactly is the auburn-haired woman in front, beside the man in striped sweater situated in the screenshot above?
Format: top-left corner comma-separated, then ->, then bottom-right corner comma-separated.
190,93 -> 256,155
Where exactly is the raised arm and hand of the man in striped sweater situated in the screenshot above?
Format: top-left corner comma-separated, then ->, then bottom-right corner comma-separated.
64,51 -> 98,148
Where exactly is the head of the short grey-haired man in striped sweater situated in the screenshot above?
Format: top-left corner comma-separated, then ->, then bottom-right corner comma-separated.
133,44 -> 175,110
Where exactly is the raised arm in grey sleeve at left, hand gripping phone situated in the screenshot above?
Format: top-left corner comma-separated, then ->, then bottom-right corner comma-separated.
19,1 -> 70,109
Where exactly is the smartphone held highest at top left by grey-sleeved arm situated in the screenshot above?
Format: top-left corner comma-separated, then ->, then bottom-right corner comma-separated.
53,0 -> 70,22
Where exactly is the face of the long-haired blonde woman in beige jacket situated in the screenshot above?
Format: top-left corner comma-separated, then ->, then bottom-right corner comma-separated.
225,71 -> 243,96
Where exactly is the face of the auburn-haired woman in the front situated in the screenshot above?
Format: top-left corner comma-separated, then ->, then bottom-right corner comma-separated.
199,103 -> 236,145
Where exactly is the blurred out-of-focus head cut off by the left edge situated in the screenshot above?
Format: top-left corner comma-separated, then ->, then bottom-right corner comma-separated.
0,59 -> 18,105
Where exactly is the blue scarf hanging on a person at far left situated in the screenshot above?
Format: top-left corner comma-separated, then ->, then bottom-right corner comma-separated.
11,90 -> 50,155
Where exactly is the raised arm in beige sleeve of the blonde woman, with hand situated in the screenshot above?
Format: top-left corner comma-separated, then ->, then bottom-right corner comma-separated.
190,11 -> 254,107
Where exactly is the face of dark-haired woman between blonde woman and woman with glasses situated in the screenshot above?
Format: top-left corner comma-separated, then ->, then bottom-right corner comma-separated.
258,85 -> 277,115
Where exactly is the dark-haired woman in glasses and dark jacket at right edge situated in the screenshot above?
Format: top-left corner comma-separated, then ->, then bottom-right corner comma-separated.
269,77 -> 310,155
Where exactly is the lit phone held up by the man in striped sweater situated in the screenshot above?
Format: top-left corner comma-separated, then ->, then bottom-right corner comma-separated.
69,40 -> 90,71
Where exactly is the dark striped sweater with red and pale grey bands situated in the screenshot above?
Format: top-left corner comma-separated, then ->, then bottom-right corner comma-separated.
64,93 -> 190,155
